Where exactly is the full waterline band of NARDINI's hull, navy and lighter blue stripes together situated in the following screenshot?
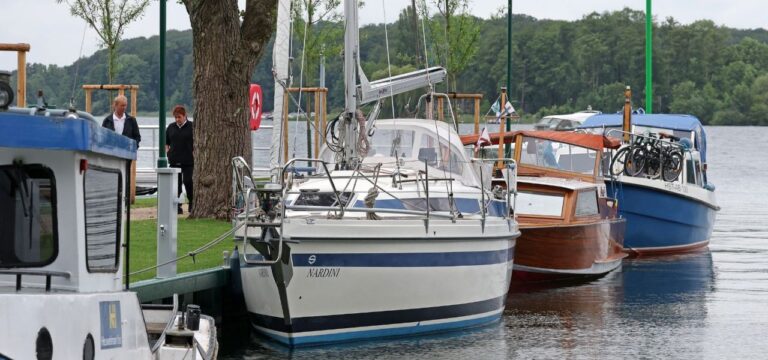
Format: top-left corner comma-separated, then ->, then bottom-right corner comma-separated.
250,296 -> 506,346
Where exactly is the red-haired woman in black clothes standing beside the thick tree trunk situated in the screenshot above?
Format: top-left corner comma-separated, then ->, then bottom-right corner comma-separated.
165,105 -> 195,214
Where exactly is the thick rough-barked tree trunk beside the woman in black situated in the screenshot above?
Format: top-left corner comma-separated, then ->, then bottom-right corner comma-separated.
180,0 -> 277,219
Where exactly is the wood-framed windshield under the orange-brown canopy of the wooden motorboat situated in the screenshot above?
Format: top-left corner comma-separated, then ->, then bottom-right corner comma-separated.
520,136 -> 597,174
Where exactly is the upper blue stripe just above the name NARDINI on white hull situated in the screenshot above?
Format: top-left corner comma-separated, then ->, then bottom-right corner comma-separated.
242,246 -> 515,267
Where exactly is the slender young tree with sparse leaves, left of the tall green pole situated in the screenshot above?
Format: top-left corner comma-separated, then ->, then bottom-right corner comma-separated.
56,0 -> 149,83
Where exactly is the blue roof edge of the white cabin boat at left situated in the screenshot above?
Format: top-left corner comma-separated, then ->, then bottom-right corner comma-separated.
0,112 -> 137,160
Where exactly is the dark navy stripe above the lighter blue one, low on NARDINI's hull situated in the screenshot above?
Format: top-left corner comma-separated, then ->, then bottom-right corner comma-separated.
250,296 -> 506,340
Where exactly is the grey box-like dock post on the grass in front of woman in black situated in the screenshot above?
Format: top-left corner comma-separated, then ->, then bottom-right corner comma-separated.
156,168 -> 180,278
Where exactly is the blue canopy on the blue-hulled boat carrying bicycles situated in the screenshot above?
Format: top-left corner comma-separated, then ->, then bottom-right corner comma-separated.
579,114 -> 707,163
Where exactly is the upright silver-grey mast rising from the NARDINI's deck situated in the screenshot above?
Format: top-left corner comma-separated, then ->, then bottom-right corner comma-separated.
341,0 -> 359,169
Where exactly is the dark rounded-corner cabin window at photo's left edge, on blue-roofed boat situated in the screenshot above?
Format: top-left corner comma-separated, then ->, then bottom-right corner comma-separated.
0,164 -> 59,268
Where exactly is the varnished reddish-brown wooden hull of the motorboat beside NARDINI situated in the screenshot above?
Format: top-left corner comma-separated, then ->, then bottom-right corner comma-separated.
512,219 -> 627,282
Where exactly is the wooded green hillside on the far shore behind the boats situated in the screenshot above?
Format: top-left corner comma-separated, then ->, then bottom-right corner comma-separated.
12,7 -> 768,125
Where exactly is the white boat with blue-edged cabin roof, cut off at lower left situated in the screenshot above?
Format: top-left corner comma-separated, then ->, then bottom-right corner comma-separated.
0,100 -> 217,359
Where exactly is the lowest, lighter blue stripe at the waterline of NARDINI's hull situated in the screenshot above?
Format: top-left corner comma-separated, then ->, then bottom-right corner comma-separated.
255,312 -> 501,347
